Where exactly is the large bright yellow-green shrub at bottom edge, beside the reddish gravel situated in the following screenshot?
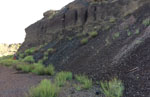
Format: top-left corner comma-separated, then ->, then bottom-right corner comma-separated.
28,79 -> 59,97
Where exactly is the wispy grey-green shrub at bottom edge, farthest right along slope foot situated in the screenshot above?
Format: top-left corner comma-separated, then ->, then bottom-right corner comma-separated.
100,78 -> 124,97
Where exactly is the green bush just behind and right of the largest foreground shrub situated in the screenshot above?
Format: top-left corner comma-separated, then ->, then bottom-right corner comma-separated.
55,71 -> 72,87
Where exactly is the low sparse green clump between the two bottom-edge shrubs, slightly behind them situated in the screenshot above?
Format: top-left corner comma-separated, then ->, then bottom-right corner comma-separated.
75,75 -> 92,89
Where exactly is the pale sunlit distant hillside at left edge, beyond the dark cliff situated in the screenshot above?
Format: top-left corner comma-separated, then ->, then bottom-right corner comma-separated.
0,44 -> 21,57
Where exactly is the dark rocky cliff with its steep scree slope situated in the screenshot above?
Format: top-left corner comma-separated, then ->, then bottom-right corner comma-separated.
19,0 -> 150,97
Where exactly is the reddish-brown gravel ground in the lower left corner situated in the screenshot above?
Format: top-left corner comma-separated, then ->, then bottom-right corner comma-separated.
0,66 -> 48,97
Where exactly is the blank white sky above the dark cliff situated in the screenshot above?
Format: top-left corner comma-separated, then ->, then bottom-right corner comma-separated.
0,0 -> 74,44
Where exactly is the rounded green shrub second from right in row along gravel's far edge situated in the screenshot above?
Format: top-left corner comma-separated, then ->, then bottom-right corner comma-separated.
32,63 -> 45,75
